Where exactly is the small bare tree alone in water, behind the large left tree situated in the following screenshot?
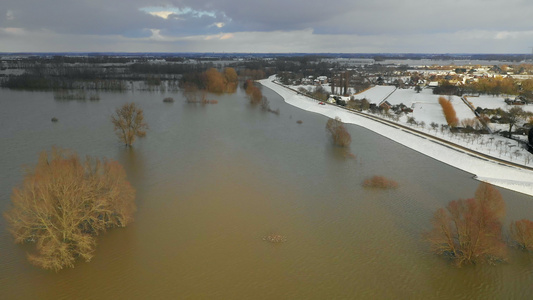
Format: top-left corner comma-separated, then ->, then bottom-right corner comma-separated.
111,103 -> 148,147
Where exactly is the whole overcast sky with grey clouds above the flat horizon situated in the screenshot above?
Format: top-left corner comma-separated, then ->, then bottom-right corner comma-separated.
0,0 -> 533,53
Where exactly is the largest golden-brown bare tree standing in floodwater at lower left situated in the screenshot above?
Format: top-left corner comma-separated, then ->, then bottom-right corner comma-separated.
4,148 -> 135,271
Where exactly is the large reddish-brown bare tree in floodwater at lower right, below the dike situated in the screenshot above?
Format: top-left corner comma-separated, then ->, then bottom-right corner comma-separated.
427,183 -> 506,266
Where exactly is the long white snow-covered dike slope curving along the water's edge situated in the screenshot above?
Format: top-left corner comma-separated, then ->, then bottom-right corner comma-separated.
259,79 -> 533,195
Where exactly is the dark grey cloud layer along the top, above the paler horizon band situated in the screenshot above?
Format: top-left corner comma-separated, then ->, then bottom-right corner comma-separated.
4,0 -> 533,36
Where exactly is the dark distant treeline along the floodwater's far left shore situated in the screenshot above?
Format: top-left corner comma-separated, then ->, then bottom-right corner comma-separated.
0,57 -> 267,93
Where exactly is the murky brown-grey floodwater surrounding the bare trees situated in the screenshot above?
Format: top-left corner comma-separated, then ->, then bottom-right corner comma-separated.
0,84 -> 533,299
